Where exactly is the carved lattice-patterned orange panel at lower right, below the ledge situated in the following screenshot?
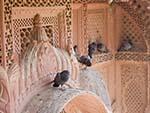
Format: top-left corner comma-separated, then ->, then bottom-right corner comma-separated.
121,64 -> 147,113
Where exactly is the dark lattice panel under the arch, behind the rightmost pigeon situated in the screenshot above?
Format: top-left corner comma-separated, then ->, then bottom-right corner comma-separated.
121,12 -> 147,52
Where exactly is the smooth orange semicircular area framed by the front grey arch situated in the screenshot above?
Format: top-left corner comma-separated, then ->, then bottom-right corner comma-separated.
62,94 -> 108,113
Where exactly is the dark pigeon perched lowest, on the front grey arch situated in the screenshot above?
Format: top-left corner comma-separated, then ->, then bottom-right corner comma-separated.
50,70 -> 70,87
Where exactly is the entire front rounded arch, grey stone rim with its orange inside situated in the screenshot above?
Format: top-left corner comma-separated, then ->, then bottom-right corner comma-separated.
22,88 -> 110,113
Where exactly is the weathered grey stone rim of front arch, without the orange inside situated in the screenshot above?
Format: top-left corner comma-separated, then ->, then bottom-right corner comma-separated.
22,87 -> 107,113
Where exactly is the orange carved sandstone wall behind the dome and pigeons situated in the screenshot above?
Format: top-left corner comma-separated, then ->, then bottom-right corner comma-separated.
0,0 -> 150,113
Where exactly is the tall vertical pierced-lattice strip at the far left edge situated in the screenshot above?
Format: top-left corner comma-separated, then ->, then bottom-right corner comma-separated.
2,0 -> 13,68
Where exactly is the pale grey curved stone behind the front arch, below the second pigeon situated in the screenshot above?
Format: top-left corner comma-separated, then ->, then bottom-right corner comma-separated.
79,68 -> 111,111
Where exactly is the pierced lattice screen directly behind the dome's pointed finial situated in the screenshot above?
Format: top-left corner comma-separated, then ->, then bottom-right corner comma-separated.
13,17 -> 59,54
